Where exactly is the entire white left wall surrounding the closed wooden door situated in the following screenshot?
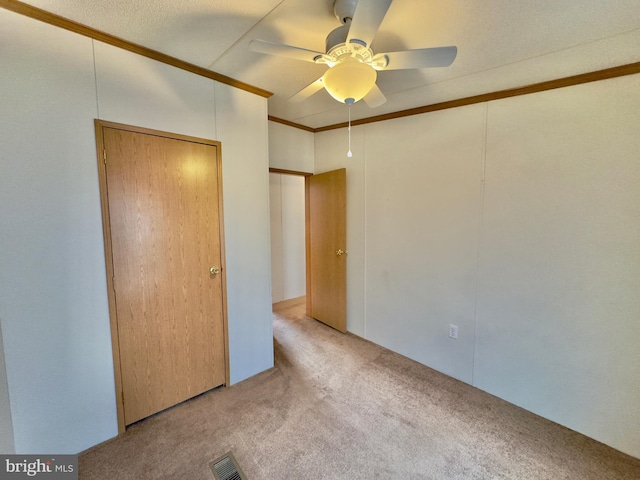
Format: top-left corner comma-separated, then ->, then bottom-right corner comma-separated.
0,10 -> 273,453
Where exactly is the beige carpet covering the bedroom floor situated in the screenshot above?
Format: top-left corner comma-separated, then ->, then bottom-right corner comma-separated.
79,306 -> 640,480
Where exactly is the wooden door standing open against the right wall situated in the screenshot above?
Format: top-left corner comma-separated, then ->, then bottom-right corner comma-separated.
306,168 -> 347,332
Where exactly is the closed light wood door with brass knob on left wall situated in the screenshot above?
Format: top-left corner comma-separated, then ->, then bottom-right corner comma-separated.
103,128 -> 226,425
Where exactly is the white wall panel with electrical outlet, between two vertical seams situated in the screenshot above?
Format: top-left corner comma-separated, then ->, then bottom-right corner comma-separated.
365,105 -> 486,383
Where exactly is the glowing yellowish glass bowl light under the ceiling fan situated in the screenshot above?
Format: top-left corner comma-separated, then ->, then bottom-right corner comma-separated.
322,59 -> 378,105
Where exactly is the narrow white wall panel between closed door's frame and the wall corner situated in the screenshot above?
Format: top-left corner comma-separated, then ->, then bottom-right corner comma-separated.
215,83 -> 273,384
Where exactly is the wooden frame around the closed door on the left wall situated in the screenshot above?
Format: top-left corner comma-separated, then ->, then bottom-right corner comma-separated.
94,119 -> 230,434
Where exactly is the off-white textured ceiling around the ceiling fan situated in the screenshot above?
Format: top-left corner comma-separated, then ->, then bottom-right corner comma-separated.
17,0 -> 640,128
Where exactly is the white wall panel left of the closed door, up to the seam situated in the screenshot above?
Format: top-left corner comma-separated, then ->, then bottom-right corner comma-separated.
0,10 -> 117,453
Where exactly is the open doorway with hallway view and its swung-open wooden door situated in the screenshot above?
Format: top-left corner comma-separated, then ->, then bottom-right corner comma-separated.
269,168 -> 348,333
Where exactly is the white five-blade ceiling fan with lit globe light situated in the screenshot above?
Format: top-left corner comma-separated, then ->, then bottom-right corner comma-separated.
249,0 -> 458,108
